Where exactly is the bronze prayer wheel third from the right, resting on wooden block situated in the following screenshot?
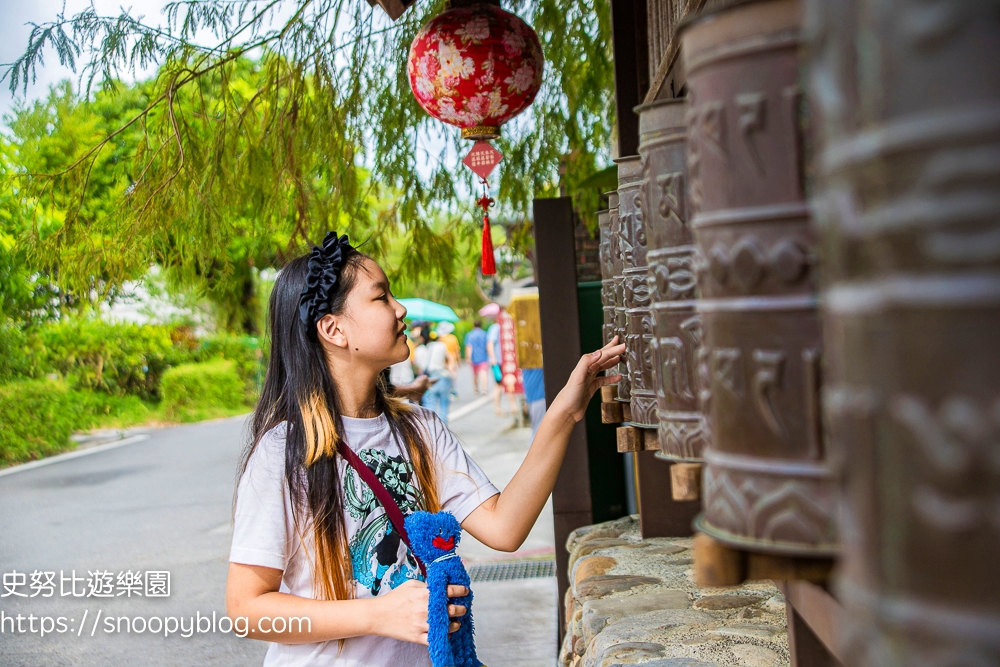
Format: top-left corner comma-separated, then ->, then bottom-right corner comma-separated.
637,100 -> 708,461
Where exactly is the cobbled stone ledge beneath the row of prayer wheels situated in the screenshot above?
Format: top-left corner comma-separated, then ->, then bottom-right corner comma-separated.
559,516 -> 789,667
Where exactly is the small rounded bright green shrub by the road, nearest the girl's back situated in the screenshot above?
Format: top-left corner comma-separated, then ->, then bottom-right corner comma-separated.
160,359 -> 246,422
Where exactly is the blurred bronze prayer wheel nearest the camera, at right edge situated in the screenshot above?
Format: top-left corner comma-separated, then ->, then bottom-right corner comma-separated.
808,0 -> 1000,667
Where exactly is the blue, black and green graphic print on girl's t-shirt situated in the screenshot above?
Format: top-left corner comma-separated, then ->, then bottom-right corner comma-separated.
344,449 -> 421,596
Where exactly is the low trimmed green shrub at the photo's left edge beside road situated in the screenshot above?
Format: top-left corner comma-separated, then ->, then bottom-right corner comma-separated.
0,380 -> 81,466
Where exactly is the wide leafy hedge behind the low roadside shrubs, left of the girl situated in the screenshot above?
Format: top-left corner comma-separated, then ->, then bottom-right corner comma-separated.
35,317 -> 183,399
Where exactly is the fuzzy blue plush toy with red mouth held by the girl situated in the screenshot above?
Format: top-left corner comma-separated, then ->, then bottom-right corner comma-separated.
404,512 -> 483,667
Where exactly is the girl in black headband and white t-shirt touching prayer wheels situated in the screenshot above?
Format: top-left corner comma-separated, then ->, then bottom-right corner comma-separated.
226,233 -> 625,667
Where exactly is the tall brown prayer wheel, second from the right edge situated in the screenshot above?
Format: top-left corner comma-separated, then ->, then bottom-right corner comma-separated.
679,0 -> 837,556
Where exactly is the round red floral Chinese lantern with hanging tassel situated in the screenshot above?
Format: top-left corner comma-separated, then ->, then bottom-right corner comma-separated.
407,3 -> 545,275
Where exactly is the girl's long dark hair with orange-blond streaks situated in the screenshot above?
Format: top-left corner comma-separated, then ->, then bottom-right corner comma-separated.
234,248 -> 440,600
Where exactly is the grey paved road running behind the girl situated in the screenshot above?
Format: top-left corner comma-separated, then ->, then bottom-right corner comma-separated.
0,368 -> 556,667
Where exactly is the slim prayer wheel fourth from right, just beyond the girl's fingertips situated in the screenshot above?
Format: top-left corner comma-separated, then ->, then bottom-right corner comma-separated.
615,155 -> 656,428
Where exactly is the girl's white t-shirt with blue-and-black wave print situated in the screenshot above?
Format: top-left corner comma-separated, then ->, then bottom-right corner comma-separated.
229,406 -> 499,667
